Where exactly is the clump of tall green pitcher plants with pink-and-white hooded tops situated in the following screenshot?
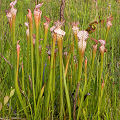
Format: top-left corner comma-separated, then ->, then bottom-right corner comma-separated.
0,0 -> 113,120
